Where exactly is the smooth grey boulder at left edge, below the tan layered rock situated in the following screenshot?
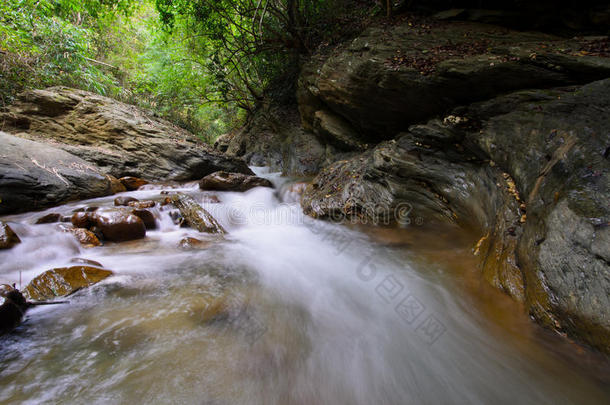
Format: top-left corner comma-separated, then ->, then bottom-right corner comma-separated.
0,132 -> 112,215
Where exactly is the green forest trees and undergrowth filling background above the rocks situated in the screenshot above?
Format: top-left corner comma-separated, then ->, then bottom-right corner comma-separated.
0,0 -> 370,141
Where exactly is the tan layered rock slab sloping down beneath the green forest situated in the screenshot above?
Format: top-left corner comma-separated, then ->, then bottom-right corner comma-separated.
0,87 -> 252,180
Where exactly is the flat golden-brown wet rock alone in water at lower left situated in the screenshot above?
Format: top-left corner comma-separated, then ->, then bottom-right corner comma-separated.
23,266 -> 114,301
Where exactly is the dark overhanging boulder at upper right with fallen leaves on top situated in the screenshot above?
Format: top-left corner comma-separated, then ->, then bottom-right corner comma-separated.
298,19 -> 610,141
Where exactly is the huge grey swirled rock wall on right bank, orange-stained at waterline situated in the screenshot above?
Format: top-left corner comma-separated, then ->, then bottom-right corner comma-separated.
302,79 -> 610,352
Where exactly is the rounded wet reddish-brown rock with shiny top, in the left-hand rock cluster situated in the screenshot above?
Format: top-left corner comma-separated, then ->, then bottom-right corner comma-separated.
93,210 -> 146,242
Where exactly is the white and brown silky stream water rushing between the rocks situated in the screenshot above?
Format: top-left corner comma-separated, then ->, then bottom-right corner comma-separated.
0,170 -> 610,405
